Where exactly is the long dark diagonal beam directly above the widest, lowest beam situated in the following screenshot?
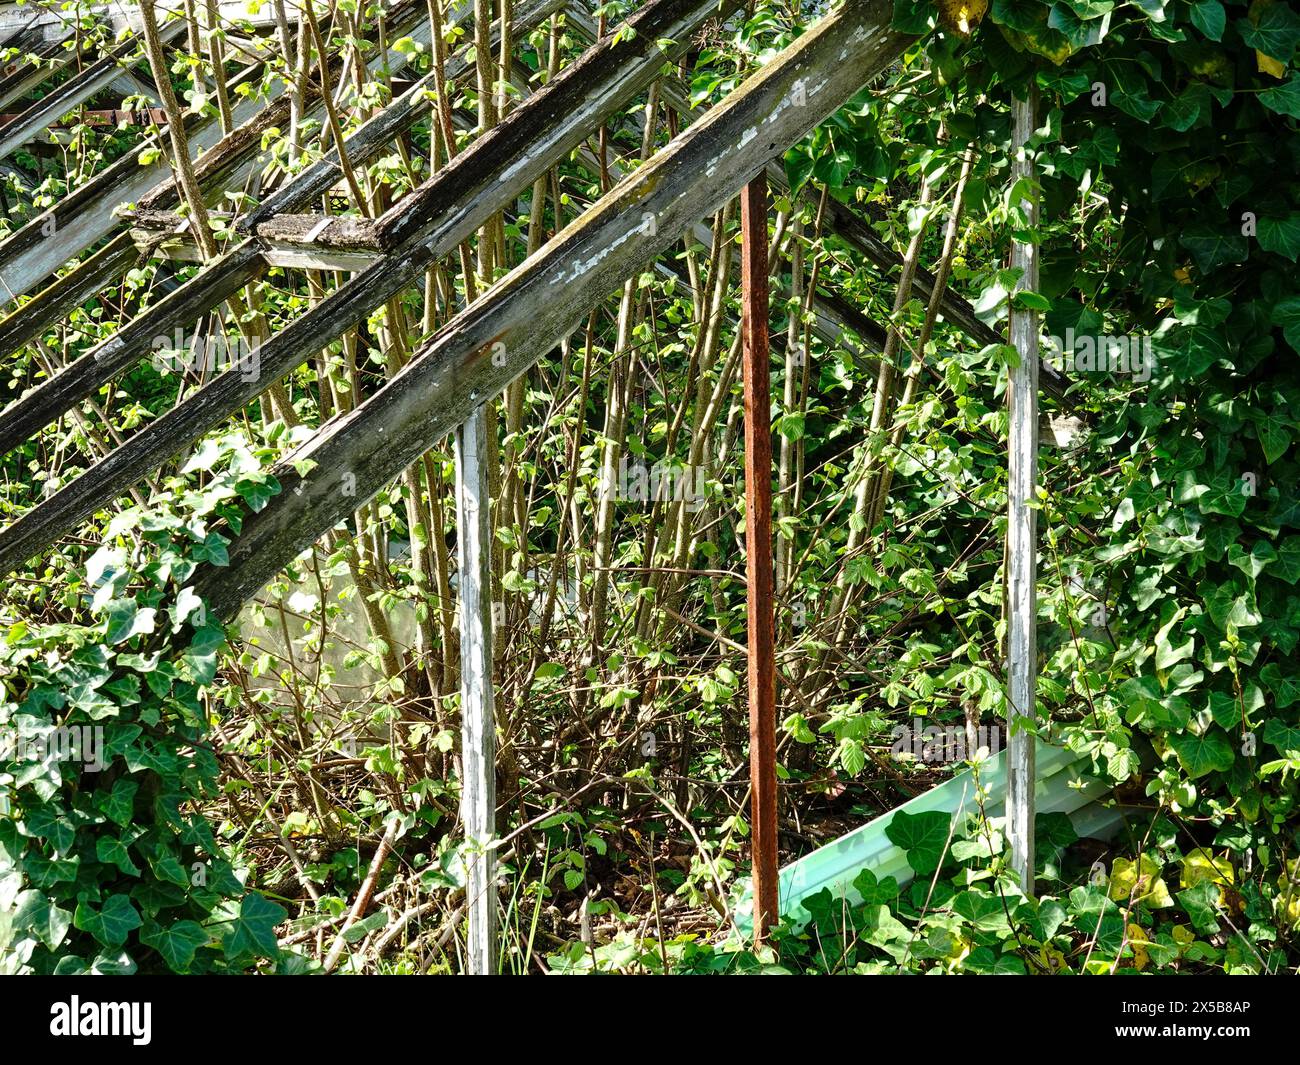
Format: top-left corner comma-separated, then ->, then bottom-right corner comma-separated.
0,0 -> 738,572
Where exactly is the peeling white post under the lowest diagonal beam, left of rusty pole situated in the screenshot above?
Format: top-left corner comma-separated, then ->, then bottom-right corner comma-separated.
455,407 -> 497,975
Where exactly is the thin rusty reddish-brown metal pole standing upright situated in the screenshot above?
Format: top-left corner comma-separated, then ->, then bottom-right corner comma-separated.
740,172 -> 780,943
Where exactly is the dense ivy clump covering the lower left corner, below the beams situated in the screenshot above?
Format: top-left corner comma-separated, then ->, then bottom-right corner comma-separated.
0,441 -> 286,974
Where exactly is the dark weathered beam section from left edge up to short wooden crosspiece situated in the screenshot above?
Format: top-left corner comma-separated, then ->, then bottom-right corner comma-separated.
0,241 -> 265,460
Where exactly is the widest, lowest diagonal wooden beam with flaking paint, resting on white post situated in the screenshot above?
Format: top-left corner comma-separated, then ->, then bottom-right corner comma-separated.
195,0 -> 910,618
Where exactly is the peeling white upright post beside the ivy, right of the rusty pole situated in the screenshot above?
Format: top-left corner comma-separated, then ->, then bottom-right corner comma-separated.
1006,86 -> 1039,895
